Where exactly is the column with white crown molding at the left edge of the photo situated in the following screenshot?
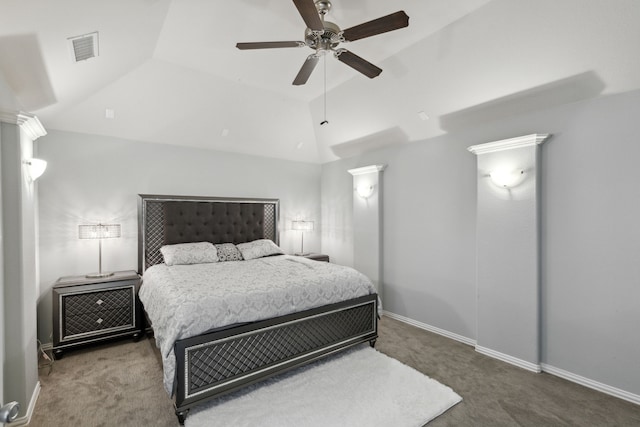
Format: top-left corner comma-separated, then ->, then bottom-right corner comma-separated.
0,111 -> 46,425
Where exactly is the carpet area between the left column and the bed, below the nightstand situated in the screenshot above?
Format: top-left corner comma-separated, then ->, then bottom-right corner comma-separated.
29,339 -> 174,427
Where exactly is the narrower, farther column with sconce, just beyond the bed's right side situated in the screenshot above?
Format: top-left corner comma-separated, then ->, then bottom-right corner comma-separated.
349,165 -> 387,297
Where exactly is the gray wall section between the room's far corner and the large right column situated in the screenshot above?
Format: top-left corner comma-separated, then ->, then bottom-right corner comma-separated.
322,129 -> 476,338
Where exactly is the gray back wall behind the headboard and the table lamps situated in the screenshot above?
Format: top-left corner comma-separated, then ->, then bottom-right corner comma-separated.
37,131 -> 321,343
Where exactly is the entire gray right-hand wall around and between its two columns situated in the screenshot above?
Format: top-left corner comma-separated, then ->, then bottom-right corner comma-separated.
321,91 -> 640,396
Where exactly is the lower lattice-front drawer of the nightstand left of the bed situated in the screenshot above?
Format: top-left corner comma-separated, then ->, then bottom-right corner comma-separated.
62,306 -> 134,341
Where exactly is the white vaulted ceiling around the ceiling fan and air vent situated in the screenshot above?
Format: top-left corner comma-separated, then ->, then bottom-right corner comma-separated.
0,0 -> 640,163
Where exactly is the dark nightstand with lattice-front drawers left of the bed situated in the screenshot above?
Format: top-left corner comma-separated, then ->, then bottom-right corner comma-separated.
52,271 -> 142,358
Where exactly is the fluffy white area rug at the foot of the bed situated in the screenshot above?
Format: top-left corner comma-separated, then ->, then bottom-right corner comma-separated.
185,346 -> 462,427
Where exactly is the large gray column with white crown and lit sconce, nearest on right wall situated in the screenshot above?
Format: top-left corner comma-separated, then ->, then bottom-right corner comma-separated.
469,134 -> 548,372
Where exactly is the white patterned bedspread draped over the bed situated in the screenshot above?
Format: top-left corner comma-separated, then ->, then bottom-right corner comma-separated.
140,255 -> 375,395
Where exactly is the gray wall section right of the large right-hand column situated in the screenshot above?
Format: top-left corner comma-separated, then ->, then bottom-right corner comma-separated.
541,91 -> 640,395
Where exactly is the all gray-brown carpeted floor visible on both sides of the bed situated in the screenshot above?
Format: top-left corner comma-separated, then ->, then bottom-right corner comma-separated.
30,318 -> 640,427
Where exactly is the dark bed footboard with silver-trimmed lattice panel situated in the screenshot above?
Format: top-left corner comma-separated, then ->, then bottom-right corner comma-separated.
175,295 -> 378,423
